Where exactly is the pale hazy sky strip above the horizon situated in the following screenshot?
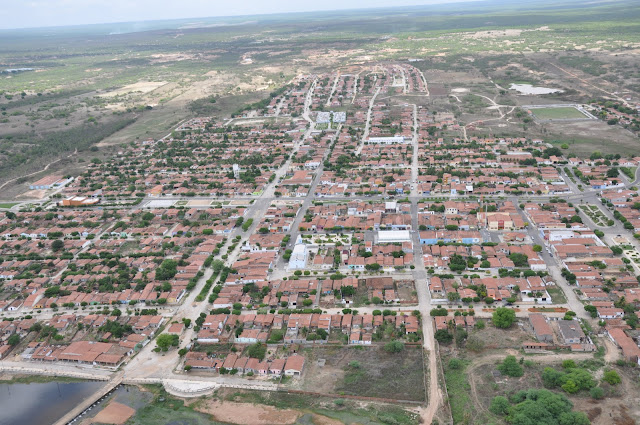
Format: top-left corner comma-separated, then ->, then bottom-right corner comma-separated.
0,0 -> 470,29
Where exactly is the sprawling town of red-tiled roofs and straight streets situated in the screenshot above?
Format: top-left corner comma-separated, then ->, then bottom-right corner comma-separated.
0,58 -> 640,423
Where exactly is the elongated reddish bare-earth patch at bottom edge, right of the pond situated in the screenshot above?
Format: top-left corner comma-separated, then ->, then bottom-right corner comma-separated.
196,400 -> 302,425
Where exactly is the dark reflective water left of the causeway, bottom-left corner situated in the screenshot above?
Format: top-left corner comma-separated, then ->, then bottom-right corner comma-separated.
0,381 -> 105,425
